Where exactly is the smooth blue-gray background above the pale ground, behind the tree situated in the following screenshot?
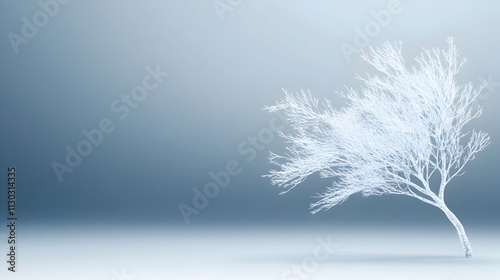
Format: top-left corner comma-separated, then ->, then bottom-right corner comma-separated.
0,0 -> 500,230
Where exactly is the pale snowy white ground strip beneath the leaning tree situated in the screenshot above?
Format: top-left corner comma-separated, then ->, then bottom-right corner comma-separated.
0,225 -> 500,280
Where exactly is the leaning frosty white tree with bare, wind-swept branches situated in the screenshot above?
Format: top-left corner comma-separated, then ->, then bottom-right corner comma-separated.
265,38 -> 490,257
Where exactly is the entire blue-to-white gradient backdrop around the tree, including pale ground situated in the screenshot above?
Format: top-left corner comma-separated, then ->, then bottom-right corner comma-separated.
0,0 -> 500,280
